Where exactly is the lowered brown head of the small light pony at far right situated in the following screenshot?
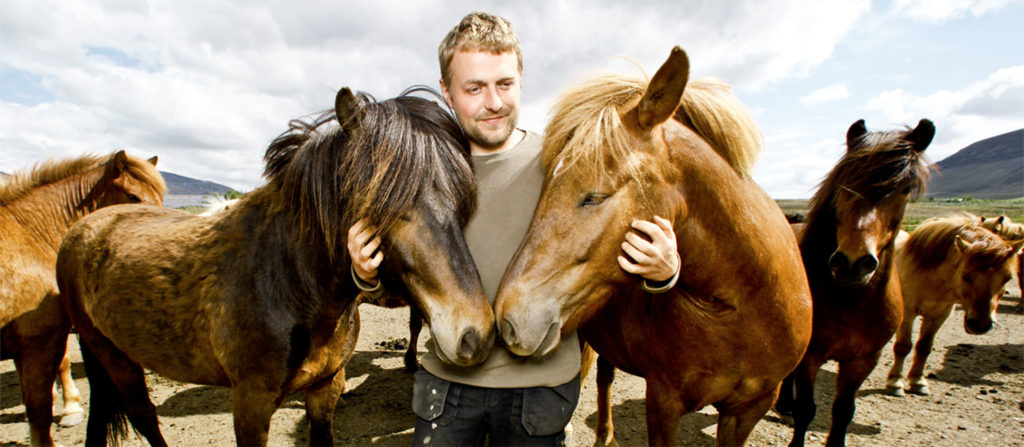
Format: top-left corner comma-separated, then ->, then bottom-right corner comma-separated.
952,232 -> 1024,334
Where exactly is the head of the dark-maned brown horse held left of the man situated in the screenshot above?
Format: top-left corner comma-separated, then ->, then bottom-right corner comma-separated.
335,89 -> 495,366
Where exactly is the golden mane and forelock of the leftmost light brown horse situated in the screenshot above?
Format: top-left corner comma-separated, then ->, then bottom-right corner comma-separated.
0,153 -> 167,203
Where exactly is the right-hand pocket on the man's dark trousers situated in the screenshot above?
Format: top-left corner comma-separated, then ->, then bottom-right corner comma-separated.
522,375 -> 580,436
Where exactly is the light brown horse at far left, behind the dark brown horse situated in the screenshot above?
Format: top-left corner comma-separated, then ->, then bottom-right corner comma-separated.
0,150 -> 167,446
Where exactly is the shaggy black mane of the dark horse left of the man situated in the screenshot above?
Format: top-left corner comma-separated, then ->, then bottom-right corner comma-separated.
263,86 -> 476,254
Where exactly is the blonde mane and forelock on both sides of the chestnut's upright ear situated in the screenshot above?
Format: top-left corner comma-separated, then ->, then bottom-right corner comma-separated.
542,73 -> 763,179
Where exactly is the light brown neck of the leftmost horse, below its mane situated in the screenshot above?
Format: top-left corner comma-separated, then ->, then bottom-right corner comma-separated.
5,169 -> 102,252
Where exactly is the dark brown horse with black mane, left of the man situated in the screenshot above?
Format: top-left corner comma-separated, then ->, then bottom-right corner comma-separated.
56,87 -> 496,446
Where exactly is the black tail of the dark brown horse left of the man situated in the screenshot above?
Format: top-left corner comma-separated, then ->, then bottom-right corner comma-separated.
79,343 -> 128,446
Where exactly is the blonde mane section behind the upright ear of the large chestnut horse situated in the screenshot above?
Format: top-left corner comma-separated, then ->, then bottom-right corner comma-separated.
676,78 -> 764,178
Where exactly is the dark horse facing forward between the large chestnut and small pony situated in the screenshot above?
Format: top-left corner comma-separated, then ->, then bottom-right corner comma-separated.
776,116 -> 935,446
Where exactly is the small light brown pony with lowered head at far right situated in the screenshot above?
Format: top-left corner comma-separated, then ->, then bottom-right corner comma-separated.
886,215 -> 1024,396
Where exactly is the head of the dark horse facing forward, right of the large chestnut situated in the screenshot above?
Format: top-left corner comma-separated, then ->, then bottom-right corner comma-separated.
812,120 -> 935,286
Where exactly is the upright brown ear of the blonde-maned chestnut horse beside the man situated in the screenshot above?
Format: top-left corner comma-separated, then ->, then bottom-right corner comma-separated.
636,46 -> 690,130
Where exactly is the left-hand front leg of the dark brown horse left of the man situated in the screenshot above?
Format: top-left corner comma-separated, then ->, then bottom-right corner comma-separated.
231,381 -> 282,446
